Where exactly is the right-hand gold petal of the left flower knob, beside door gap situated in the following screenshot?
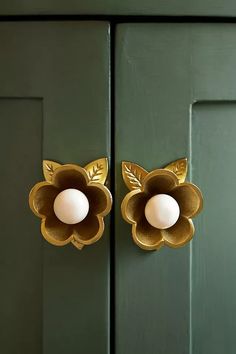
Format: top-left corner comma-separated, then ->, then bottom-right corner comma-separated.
85,182 -> 112,216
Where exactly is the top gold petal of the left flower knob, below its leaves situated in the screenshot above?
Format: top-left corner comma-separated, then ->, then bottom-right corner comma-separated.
52,164 -> 89,191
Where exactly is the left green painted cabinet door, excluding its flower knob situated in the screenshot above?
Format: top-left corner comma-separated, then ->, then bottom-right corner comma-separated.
0,21 -> 110,354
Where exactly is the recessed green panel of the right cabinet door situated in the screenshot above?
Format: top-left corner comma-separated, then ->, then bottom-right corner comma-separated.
192,101 -> 236,354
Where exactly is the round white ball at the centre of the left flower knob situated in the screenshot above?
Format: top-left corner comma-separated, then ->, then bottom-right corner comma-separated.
53,188 -> 89,224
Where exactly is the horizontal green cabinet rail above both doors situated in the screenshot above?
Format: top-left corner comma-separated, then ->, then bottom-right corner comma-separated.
0,0 -> 236,17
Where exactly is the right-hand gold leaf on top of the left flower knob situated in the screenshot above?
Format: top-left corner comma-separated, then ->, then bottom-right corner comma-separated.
85,157 -> 108,184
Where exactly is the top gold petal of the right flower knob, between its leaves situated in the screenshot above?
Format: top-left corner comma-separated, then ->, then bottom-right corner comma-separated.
143,169 -> 179,196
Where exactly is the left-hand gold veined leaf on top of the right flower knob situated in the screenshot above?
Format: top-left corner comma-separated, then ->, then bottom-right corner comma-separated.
122,161 -> 148,190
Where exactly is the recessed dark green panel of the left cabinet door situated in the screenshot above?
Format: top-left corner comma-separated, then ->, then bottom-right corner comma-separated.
0,98 -> 43,354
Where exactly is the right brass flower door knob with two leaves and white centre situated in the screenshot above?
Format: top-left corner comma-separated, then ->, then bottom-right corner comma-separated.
121,159 -> 203,250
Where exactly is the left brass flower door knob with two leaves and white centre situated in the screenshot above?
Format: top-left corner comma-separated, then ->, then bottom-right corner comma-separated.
29,158 -> 112,249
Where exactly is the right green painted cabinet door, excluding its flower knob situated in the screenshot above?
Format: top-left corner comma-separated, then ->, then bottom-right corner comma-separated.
115,23 -> 236,354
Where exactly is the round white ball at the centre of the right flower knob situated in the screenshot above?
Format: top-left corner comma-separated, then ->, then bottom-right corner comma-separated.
145,194 -> 180,229
